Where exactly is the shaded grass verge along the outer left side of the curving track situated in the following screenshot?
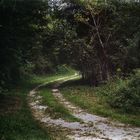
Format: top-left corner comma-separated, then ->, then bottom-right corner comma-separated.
0,70 -> 75,140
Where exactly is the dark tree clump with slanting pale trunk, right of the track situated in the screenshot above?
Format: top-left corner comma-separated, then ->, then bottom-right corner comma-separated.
57,1 -> 140,85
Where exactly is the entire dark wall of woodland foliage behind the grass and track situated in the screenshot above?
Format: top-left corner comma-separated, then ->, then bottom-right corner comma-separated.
0,0 -> 140,87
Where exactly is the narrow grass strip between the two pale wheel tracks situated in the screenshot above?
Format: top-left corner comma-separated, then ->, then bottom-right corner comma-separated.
40,87 -> 80,122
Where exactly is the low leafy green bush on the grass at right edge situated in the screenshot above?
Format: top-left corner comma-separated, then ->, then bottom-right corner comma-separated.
108,73 -> 140,112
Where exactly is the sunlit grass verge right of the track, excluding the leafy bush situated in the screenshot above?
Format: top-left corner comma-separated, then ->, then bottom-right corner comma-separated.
61,80 -> 140,126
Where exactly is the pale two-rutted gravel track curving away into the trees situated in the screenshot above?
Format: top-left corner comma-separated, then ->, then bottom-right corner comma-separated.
28,74 -> 140,140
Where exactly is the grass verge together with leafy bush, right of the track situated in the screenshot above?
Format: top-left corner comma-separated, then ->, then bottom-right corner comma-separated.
61,71 -> 140,126
